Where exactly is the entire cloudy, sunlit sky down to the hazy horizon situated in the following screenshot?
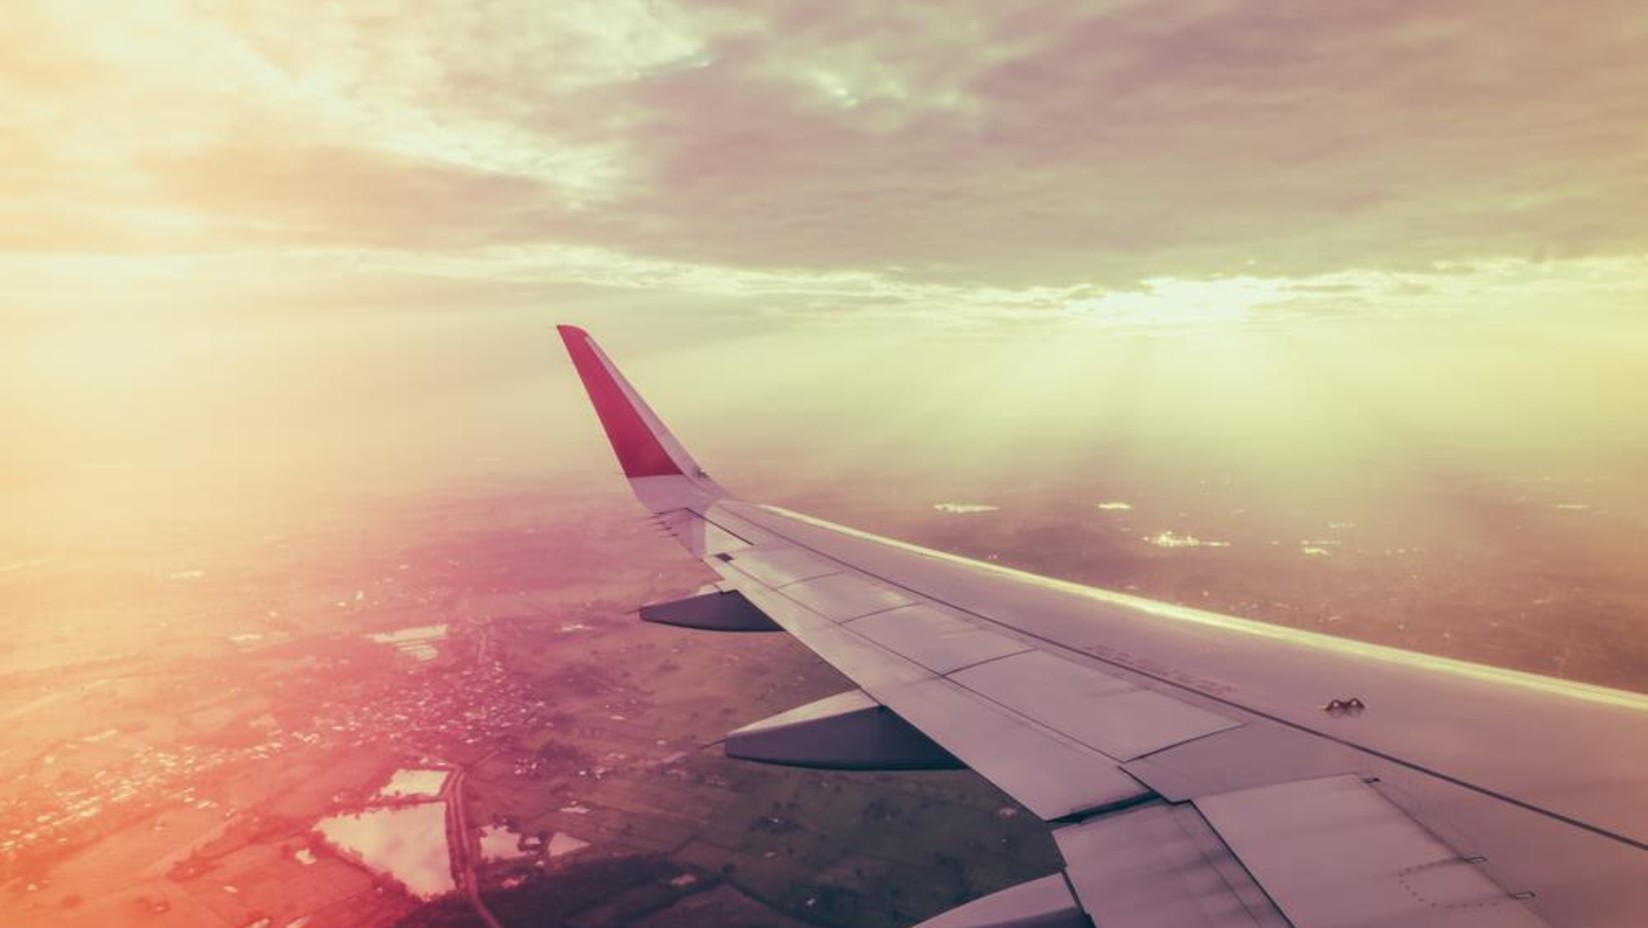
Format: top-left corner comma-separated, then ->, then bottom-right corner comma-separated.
0,0 -> 1648,540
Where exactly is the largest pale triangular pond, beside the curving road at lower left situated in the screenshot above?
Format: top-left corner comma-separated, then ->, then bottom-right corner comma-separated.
315,803 -> 456,898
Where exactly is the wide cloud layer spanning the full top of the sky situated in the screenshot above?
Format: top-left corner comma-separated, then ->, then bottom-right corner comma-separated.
0,0 -> 1648,326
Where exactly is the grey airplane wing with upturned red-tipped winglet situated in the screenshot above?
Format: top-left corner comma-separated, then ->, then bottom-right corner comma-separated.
560,326 -> 1648,928
